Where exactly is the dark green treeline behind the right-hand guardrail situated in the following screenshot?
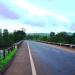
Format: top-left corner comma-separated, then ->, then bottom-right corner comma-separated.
27,32 -> 75,44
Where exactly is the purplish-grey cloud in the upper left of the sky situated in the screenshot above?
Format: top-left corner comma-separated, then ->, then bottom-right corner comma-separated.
0,2 -> 19,19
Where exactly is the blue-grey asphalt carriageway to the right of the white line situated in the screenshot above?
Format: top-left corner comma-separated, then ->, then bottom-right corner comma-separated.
27,41 -> 75,75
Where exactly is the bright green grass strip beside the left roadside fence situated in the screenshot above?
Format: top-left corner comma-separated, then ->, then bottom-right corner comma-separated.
0,48 -> 16,71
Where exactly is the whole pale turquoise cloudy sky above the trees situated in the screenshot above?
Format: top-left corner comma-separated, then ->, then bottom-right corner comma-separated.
0,0 -> 75,33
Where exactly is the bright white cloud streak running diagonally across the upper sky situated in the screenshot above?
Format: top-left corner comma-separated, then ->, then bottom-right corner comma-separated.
11,0 -> 70,22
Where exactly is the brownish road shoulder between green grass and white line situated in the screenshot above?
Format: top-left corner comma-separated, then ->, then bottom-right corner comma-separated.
4,42 -> 32,75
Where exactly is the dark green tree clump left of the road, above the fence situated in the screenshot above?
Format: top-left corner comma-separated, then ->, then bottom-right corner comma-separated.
0,29 -> 26,48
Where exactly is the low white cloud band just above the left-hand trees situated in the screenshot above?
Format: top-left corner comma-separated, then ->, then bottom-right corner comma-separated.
0,20 -> 44,33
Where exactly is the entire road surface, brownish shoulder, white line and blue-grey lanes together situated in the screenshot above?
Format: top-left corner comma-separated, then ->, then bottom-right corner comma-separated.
4,41 -> 75,75
